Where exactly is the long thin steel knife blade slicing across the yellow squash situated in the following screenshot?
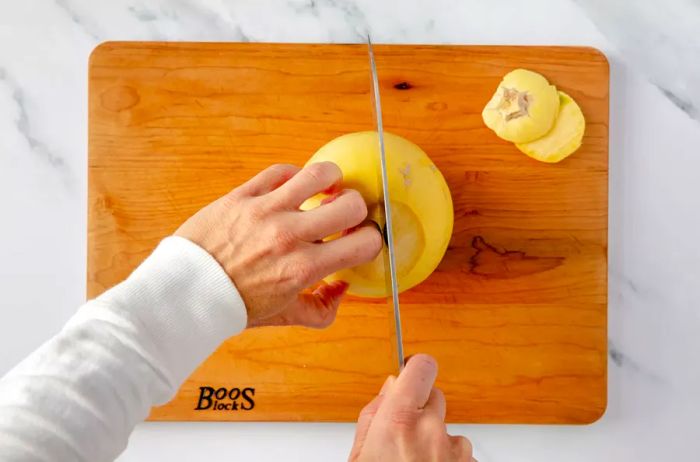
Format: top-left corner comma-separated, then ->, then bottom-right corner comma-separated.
367,34 -> 404,372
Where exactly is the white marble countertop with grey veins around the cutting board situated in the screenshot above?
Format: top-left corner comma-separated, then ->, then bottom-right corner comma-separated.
0,0 -> 700,462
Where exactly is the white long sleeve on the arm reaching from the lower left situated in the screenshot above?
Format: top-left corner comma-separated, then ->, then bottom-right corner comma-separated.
0,237 -> 246,462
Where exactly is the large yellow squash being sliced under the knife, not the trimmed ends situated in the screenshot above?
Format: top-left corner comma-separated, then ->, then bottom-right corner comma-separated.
301,132 -> 454,297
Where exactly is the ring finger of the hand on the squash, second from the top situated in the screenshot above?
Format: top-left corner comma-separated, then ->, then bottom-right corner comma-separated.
274,162 -> 343,210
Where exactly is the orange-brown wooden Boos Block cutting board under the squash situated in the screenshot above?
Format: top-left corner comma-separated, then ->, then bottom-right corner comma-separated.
88,42 -> 608,423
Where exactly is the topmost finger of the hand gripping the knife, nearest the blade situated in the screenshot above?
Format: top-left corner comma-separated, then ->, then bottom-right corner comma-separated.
388,354 -> 437,409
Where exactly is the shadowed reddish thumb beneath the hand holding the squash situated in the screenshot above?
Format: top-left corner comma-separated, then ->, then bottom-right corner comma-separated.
251,281 -> 348,329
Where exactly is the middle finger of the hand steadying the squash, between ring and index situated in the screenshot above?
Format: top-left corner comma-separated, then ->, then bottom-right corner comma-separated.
295,189 -> 367,242
